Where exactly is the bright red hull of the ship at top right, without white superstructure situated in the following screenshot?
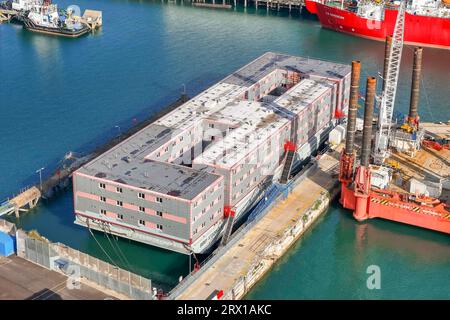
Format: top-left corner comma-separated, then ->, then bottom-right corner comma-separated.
305,0 -> 450,49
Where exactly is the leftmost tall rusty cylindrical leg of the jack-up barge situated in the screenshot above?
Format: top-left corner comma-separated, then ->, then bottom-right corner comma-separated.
345,61 -> 361,155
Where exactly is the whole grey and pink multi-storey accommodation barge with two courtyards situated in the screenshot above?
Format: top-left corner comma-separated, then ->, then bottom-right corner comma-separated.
73,53 -> 350,253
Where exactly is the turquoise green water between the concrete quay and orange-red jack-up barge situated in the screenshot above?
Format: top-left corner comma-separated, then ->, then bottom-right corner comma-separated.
246,204 -> 450,299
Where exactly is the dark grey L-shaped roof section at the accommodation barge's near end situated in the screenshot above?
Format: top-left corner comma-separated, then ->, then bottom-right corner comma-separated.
77,123 -> 220,200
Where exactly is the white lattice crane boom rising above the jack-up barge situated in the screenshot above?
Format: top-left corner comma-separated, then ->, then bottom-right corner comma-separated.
373,1 -> 406,164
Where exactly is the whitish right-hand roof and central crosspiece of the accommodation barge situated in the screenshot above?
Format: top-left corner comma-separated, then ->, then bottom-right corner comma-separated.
194,79 -> 330,168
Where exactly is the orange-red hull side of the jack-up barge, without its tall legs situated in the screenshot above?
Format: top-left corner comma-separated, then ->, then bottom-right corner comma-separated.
340,183 -> 450,234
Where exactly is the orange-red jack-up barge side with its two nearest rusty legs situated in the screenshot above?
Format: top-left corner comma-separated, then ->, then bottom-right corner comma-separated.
339,60 -> 450,234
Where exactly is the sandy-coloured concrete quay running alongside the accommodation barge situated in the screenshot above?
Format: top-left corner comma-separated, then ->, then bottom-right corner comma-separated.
169,146 -> 342,300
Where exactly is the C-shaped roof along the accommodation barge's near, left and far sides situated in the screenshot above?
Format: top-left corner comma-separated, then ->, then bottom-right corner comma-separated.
77,52 -> 351,200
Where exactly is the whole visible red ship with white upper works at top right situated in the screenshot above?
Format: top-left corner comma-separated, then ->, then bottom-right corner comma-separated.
305,0 -> 450,49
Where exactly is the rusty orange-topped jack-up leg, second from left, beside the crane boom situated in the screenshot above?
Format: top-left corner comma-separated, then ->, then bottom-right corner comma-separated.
361,77 -> 377,167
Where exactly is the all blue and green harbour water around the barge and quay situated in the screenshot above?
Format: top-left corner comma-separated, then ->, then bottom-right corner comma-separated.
0,0 -> 450,299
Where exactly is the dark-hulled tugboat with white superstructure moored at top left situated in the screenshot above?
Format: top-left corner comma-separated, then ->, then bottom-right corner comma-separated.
19,1 -> 90,38
